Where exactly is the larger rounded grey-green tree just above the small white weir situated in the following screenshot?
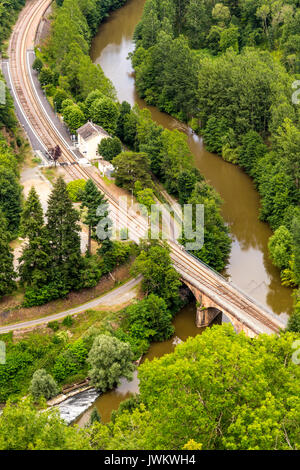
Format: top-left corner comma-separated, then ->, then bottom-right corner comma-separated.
87,335 -> 134,392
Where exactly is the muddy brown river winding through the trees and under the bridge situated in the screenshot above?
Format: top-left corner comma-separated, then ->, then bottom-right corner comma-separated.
78,0 -> 292,425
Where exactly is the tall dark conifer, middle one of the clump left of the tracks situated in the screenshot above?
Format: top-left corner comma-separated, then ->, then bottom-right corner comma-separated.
46,177 -> 82,288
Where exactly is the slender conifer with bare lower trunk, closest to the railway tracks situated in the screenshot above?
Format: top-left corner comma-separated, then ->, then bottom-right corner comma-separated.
81,179 -> 108,254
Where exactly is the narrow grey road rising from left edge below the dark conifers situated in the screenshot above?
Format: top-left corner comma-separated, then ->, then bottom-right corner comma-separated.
0,277 -> 141,334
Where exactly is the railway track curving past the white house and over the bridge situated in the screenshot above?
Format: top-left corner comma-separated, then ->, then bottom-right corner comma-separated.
9,0 -> 284,333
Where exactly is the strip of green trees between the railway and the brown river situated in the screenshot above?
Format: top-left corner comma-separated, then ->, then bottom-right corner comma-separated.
34,0 -> 231,271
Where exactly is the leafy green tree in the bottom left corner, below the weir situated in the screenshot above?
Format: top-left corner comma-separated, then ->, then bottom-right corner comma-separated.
0,399 -> 90,450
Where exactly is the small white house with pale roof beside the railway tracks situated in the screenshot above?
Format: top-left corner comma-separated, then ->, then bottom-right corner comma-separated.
77,121 -> 110,160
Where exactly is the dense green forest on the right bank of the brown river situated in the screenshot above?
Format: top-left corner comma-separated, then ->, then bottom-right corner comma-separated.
132,0 -> 300,300
